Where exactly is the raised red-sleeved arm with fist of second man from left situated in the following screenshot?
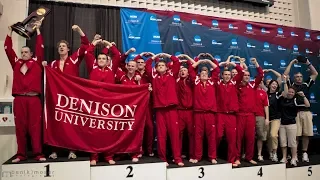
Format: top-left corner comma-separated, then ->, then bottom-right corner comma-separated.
70,25 -> 90,66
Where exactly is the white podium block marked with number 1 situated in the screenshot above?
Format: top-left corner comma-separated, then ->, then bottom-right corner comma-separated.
1,158 -> 90,180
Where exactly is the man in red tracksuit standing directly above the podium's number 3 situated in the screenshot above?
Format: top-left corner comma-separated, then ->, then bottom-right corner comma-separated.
189,59 -> 220,164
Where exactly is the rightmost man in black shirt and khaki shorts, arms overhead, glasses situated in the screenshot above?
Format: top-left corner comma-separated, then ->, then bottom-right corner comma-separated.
284,59 -> 318,162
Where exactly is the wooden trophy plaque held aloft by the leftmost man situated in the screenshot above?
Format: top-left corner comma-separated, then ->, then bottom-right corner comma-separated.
11,7 -> 50,40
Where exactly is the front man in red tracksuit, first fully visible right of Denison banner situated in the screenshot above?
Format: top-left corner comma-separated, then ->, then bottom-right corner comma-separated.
146,53 -> 184,166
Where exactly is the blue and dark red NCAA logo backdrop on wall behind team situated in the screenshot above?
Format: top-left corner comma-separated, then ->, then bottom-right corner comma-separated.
121,8 -> 320,134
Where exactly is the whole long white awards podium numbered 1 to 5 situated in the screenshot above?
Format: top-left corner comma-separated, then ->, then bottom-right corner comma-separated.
1,155 -> 320,180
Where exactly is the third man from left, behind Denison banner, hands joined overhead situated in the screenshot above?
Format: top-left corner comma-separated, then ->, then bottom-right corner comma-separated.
85,38 -> 120,165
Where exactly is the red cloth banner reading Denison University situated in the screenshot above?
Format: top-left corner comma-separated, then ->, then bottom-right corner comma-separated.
44,67 -> 149,153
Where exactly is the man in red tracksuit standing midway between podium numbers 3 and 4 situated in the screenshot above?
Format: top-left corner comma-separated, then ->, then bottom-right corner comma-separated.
216,61 -> 244,167
